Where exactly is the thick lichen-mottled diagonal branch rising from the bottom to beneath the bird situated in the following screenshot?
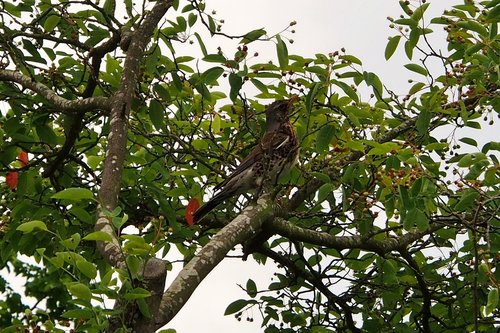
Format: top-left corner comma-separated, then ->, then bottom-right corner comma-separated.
156,195 -> 273,328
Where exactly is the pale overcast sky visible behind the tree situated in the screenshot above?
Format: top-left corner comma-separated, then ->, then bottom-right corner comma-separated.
165,0 -> 458,333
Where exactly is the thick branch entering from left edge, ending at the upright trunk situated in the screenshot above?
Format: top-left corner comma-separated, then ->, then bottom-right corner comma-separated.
0,69 -> 110,113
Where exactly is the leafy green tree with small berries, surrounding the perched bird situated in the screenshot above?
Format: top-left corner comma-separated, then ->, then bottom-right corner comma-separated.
0,0 -> 500,332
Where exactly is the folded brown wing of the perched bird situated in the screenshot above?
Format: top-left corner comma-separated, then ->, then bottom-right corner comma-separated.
214,131 -> 289,191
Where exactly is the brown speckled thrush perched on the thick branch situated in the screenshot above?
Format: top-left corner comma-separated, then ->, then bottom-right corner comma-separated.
193,95 -> 299,223
